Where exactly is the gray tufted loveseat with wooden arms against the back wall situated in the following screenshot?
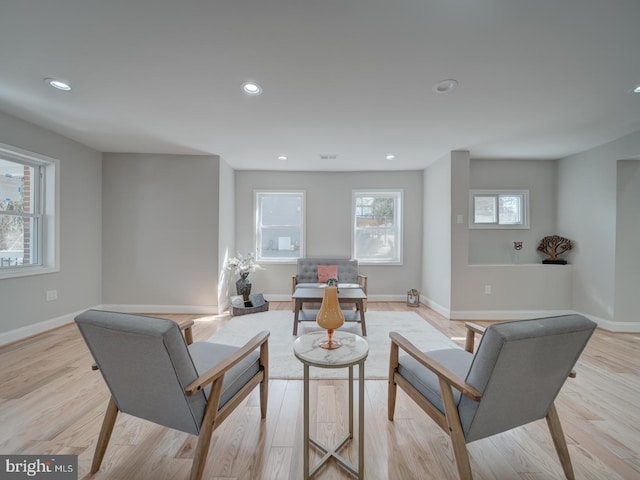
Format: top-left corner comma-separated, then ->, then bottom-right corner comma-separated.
291,258 -> 367,312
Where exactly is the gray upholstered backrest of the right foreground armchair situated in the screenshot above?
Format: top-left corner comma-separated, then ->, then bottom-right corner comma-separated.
458,315 -> 596,442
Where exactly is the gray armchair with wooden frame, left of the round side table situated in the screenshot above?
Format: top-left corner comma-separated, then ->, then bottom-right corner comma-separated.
75,310 -> 269,480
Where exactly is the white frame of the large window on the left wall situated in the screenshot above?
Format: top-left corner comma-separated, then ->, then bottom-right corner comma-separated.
0,143 -> 60,280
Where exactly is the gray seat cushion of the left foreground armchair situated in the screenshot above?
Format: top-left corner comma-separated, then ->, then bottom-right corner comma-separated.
189,342 -> 260,408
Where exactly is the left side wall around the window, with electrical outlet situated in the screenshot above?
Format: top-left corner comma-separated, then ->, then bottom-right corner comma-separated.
0,112 -> 102,344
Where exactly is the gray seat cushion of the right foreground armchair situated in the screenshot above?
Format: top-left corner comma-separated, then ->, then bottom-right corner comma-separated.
398,348 -> 473,413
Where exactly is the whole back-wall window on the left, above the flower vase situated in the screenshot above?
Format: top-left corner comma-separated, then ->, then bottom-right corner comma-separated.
254,191 -> 305,263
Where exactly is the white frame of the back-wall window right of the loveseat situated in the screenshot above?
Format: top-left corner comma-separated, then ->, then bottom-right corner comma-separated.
351,188 -> 404,265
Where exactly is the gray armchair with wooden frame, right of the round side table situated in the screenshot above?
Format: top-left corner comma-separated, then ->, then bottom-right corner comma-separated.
388,315 -> 596,480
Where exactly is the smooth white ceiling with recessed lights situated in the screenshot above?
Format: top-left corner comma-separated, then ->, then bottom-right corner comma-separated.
0,0 -> 640,171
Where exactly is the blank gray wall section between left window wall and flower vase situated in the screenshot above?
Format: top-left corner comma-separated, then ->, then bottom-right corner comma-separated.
103,153 -> 220,311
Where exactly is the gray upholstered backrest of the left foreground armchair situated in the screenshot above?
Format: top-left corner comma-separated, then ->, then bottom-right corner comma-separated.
75,310 -> 207,435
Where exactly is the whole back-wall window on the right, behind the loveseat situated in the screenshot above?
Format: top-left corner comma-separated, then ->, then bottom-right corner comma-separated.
353,190 -> 403,265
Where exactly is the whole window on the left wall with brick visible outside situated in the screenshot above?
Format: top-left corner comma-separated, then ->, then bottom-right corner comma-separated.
0,144 -> 58,278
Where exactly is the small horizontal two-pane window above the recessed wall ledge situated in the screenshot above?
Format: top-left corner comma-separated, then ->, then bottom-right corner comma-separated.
469,190 -> 529,228
